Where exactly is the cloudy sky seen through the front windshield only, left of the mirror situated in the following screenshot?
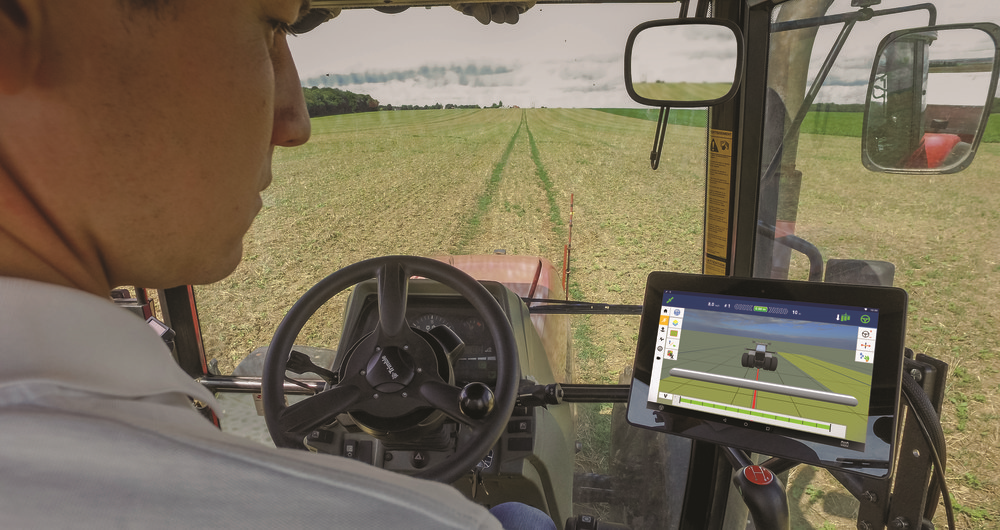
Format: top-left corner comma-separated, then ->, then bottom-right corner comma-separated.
289,5 -> 676,107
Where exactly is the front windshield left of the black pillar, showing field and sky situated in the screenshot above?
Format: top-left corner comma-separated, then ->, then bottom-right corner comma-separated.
197,1 -> 705,383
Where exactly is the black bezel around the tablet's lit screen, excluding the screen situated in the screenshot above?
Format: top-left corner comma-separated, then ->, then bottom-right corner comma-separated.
628,272 -> 907,477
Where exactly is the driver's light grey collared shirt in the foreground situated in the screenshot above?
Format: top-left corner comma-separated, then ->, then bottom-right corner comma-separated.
0,277 -> 500,529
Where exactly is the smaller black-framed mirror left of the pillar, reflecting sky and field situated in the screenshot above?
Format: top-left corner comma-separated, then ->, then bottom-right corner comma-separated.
625,19 -> 743,107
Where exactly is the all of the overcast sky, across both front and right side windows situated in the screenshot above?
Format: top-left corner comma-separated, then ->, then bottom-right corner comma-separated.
290,0 -> 1000,107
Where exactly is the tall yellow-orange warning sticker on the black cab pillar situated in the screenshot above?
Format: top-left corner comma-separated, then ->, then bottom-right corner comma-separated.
704,129 -> 733,275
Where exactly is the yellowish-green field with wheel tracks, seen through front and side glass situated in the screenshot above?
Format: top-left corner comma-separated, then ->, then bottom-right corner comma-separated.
196,109 -> 1000,528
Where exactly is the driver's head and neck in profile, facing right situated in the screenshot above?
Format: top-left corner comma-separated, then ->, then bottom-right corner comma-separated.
0,0 -> 309,292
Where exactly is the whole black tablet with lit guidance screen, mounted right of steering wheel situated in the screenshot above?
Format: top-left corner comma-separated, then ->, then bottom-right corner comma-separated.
629,273 -> 906,475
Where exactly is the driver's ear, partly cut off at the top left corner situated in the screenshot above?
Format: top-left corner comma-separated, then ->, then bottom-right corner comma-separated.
0,0 -> 43,94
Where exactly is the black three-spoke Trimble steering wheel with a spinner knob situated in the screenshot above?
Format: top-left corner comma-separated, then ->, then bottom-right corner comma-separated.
262,256 -> 520,483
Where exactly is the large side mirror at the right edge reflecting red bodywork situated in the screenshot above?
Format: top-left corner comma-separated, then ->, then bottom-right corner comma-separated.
861,23 -> 1000,173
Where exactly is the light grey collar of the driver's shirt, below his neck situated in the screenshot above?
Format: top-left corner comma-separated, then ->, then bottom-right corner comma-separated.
0,277 -> 215,404
